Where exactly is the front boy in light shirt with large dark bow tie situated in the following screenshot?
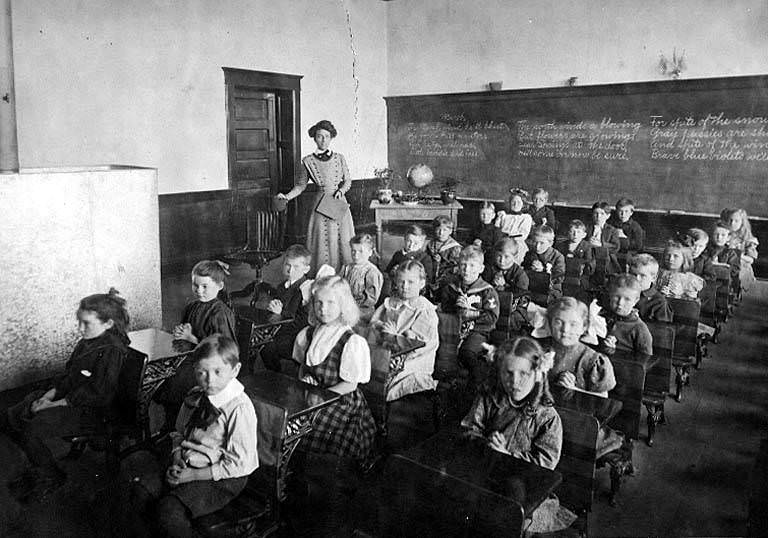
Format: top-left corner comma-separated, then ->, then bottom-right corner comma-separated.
131,334 -> 259,537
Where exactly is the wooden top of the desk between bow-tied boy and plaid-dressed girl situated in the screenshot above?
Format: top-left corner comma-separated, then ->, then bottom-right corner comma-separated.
240,370 -> 341,420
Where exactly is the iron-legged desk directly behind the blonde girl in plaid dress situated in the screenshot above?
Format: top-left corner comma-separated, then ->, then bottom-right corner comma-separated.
360,328 -> 425,438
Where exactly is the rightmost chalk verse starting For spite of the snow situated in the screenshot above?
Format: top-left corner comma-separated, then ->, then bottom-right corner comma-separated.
649,112 -> 768,161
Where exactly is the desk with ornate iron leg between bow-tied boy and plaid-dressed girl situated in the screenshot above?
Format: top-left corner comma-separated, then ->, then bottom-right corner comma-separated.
241,370 -> 341,501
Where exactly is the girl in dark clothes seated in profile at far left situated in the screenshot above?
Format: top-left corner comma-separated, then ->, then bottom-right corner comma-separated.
0,288 -> 129,502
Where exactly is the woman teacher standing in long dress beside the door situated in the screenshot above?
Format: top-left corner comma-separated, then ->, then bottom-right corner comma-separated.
277,120 -> 355,273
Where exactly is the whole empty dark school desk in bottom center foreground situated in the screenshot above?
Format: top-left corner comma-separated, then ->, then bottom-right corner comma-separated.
380,429 -> 562,536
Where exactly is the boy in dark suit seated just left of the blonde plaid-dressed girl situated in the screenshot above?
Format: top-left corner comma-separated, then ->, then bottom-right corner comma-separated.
259,245 -> 312,372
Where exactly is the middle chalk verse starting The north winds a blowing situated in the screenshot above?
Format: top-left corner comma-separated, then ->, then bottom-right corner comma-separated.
517,118 -> 642,161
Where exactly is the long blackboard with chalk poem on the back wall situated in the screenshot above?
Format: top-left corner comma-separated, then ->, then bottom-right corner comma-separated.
385,75 -> 768,216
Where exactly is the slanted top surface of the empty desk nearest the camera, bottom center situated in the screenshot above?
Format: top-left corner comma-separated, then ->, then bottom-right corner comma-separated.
398,429 -> 562,516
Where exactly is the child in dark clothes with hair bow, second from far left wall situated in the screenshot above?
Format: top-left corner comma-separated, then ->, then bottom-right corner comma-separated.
153,260 -> 237,422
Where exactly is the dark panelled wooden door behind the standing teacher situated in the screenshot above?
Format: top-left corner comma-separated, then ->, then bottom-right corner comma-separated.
227,85 -> 280,195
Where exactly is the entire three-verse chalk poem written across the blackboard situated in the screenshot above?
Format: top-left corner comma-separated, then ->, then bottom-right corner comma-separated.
406,112 -> 768,161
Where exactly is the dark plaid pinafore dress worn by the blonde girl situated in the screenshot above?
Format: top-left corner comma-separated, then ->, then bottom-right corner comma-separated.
299,327 -> 376,462
